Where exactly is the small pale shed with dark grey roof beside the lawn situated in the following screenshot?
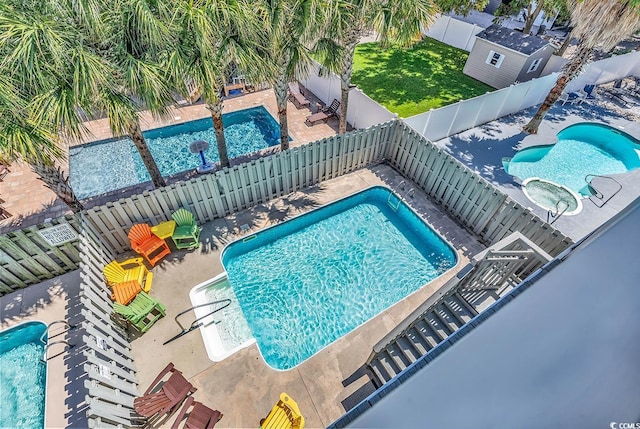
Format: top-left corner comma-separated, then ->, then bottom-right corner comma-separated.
463,24 -> 554,89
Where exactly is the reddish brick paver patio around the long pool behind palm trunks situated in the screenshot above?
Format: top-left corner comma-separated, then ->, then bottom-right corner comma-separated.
0,89 -> 338,234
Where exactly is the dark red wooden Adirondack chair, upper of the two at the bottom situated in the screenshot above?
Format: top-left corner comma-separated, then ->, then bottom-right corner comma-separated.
133,363 -> 197,424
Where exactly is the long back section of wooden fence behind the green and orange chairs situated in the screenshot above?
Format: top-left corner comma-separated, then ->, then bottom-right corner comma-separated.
82,122 -> 396,253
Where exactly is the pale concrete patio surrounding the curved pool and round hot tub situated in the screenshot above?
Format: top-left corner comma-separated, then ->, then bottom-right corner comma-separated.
435,100 -> 640,241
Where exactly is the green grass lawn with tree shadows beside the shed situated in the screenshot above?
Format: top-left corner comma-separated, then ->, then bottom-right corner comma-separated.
351,37 -> 494,118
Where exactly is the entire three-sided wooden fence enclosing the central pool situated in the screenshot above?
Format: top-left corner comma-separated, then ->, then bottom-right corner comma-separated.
52,121 -> 570,427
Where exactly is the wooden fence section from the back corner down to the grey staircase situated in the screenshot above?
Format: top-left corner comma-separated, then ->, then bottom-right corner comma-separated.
385,121 -> 573,256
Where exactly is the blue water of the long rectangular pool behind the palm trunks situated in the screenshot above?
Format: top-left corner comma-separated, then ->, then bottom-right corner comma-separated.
69,106 -> 280,198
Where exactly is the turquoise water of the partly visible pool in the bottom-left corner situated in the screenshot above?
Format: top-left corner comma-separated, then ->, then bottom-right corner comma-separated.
0,322 -> 47,428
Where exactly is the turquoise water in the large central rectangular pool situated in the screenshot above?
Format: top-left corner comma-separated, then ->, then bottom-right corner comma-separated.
222,187 -> 457,370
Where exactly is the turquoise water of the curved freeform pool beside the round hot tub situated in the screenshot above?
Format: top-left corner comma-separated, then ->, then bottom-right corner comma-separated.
505,123 -> 640,196
